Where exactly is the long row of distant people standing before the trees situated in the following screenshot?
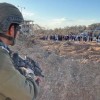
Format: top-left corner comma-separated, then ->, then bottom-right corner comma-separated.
40,32 -> 100,42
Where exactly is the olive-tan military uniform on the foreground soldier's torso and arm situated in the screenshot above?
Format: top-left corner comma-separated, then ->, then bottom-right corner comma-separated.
0,42 -> 38,100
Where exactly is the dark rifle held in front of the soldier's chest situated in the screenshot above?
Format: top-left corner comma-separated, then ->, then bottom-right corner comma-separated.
12,53 -> 44,77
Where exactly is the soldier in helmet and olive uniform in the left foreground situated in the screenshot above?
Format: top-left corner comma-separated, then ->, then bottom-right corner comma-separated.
0,3 -> 40,100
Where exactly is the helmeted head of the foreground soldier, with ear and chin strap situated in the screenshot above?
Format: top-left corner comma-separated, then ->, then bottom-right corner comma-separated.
0,3 -> 24,45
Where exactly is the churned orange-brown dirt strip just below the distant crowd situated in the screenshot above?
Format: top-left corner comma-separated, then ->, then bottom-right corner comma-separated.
41,41 -> 100,62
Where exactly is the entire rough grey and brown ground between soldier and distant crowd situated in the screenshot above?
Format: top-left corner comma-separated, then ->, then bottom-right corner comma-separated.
11,36 -> 100,100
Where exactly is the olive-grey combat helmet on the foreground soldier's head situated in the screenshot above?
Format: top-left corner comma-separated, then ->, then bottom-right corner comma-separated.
0,3 -> 24,34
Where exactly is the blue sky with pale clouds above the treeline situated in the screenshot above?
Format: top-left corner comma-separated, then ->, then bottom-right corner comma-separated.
0,0 -> 100,29
